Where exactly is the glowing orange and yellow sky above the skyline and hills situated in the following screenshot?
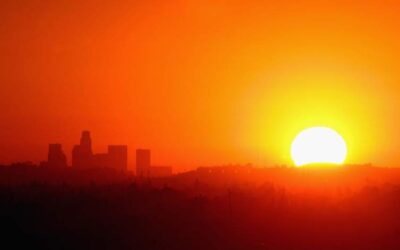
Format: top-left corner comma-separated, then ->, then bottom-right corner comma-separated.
0,0 -> 400,170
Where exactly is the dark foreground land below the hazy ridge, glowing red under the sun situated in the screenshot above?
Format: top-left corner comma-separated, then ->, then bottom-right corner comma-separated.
0,164 -> 400,250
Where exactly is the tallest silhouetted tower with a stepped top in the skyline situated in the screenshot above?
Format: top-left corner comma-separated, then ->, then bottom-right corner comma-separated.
72,131 -> 93,168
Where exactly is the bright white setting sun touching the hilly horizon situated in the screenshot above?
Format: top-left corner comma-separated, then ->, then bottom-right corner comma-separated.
291,127 -> 347,167
